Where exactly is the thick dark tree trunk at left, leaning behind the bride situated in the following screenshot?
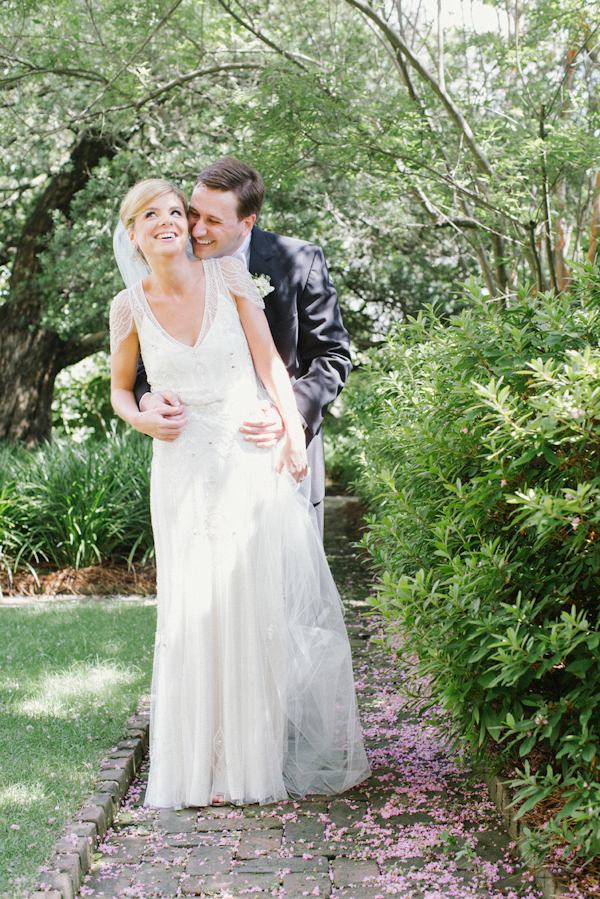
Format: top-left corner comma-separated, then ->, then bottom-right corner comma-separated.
0,131 -> 120,443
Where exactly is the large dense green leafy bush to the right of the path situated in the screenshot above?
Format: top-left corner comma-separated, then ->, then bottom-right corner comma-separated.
346,267 -> 600,872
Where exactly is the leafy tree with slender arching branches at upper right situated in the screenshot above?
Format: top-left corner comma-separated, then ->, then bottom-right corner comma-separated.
213,0 -> 599,295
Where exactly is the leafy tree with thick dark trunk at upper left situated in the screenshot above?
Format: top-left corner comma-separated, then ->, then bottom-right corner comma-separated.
0,0 -> 268,442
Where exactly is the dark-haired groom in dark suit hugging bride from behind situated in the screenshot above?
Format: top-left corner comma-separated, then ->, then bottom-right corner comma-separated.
136,156 -> 351,533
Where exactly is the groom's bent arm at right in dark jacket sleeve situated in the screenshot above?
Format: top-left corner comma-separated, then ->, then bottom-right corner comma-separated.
293,246 -> 352,441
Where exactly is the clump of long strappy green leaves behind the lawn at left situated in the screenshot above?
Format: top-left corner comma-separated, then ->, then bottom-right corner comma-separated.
0,431 -> 154,570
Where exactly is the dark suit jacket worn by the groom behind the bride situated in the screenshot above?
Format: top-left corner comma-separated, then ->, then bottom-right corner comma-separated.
134,227 -> 352,503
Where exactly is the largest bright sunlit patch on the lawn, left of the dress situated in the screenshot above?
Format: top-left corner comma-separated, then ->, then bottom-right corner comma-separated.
14,661 -> 140,718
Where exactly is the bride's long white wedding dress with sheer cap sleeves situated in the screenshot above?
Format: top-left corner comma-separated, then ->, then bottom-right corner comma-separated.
111,258 -> 369,808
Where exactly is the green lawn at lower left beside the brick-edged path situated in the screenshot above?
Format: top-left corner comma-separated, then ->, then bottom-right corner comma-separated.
0,600 -> 156,899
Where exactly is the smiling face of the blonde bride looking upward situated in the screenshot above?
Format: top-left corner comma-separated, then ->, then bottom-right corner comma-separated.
129,193 -> 188,261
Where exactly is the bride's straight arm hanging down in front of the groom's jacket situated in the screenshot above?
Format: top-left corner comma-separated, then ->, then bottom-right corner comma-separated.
235,296 -> 308,481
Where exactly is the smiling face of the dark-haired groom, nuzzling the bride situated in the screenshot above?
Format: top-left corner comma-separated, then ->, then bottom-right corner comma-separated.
188,184 -> 256,259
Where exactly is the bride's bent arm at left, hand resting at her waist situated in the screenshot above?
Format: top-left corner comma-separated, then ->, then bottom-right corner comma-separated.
110,330 -> 187,442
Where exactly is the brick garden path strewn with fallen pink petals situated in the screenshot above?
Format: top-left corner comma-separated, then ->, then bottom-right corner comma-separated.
76,498 -> 540,899
